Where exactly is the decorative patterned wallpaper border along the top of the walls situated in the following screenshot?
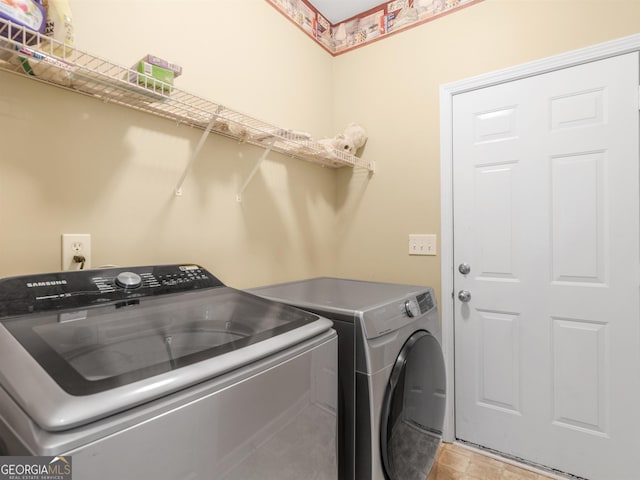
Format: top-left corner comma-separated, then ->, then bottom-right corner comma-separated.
267,0 -> 484,56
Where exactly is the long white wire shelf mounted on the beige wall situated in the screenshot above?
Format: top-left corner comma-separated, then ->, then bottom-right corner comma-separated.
0,18 -> 374,172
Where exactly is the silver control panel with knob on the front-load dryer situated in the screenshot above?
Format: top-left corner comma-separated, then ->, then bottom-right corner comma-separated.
362,289 -> 435,338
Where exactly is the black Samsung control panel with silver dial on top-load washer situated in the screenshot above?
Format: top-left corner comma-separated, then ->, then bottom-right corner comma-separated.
0,264 -> 224,318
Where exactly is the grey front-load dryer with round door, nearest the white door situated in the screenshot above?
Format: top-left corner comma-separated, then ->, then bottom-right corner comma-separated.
251,278 -> 445,480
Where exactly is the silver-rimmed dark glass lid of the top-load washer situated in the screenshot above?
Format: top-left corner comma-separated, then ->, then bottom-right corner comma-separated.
0,266 -> 331,430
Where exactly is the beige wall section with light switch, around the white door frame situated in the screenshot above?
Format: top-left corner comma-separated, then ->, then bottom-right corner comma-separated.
333,0 -> 640,304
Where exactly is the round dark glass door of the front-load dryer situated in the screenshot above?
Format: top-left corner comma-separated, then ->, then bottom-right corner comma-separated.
380,330 -> 445,480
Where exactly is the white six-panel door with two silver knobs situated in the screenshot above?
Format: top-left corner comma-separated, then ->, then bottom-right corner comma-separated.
453,53 -> 640,480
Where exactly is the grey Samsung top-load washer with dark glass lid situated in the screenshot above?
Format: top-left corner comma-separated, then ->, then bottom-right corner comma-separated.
0,265 -> 337,480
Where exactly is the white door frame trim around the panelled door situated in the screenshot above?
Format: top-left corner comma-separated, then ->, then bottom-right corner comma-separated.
440,34 -> 640,442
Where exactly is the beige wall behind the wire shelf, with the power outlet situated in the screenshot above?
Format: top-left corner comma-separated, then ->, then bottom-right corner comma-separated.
0,0 -> 336,287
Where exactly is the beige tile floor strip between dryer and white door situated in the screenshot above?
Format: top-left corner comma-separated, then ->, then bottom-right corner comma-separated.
427,443 -> 552,480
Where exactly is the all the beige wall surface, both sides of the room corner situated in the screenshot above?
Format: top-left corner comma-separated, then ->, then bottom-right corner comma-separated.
0,0 -> 640,290
